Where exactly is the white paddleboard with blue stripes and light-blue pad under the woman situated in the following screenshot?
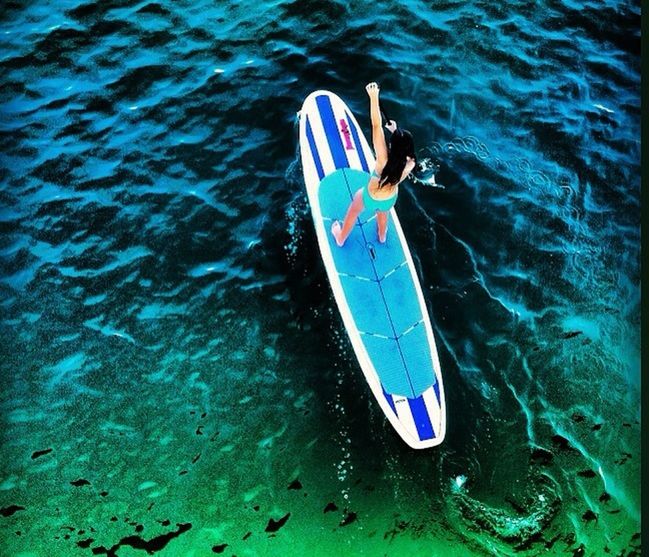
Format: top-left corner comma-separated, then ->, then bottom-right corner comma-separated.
300,91 -> 446,449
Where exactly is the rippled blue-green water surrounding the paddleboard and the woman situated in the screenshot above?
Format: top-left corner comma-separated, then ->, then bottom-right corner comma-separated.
0,0 -> 640,557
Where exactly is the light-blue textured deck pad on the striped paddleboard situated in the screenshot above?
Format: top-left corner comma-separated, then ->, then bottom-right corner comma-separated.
318,168 -> 436,399
